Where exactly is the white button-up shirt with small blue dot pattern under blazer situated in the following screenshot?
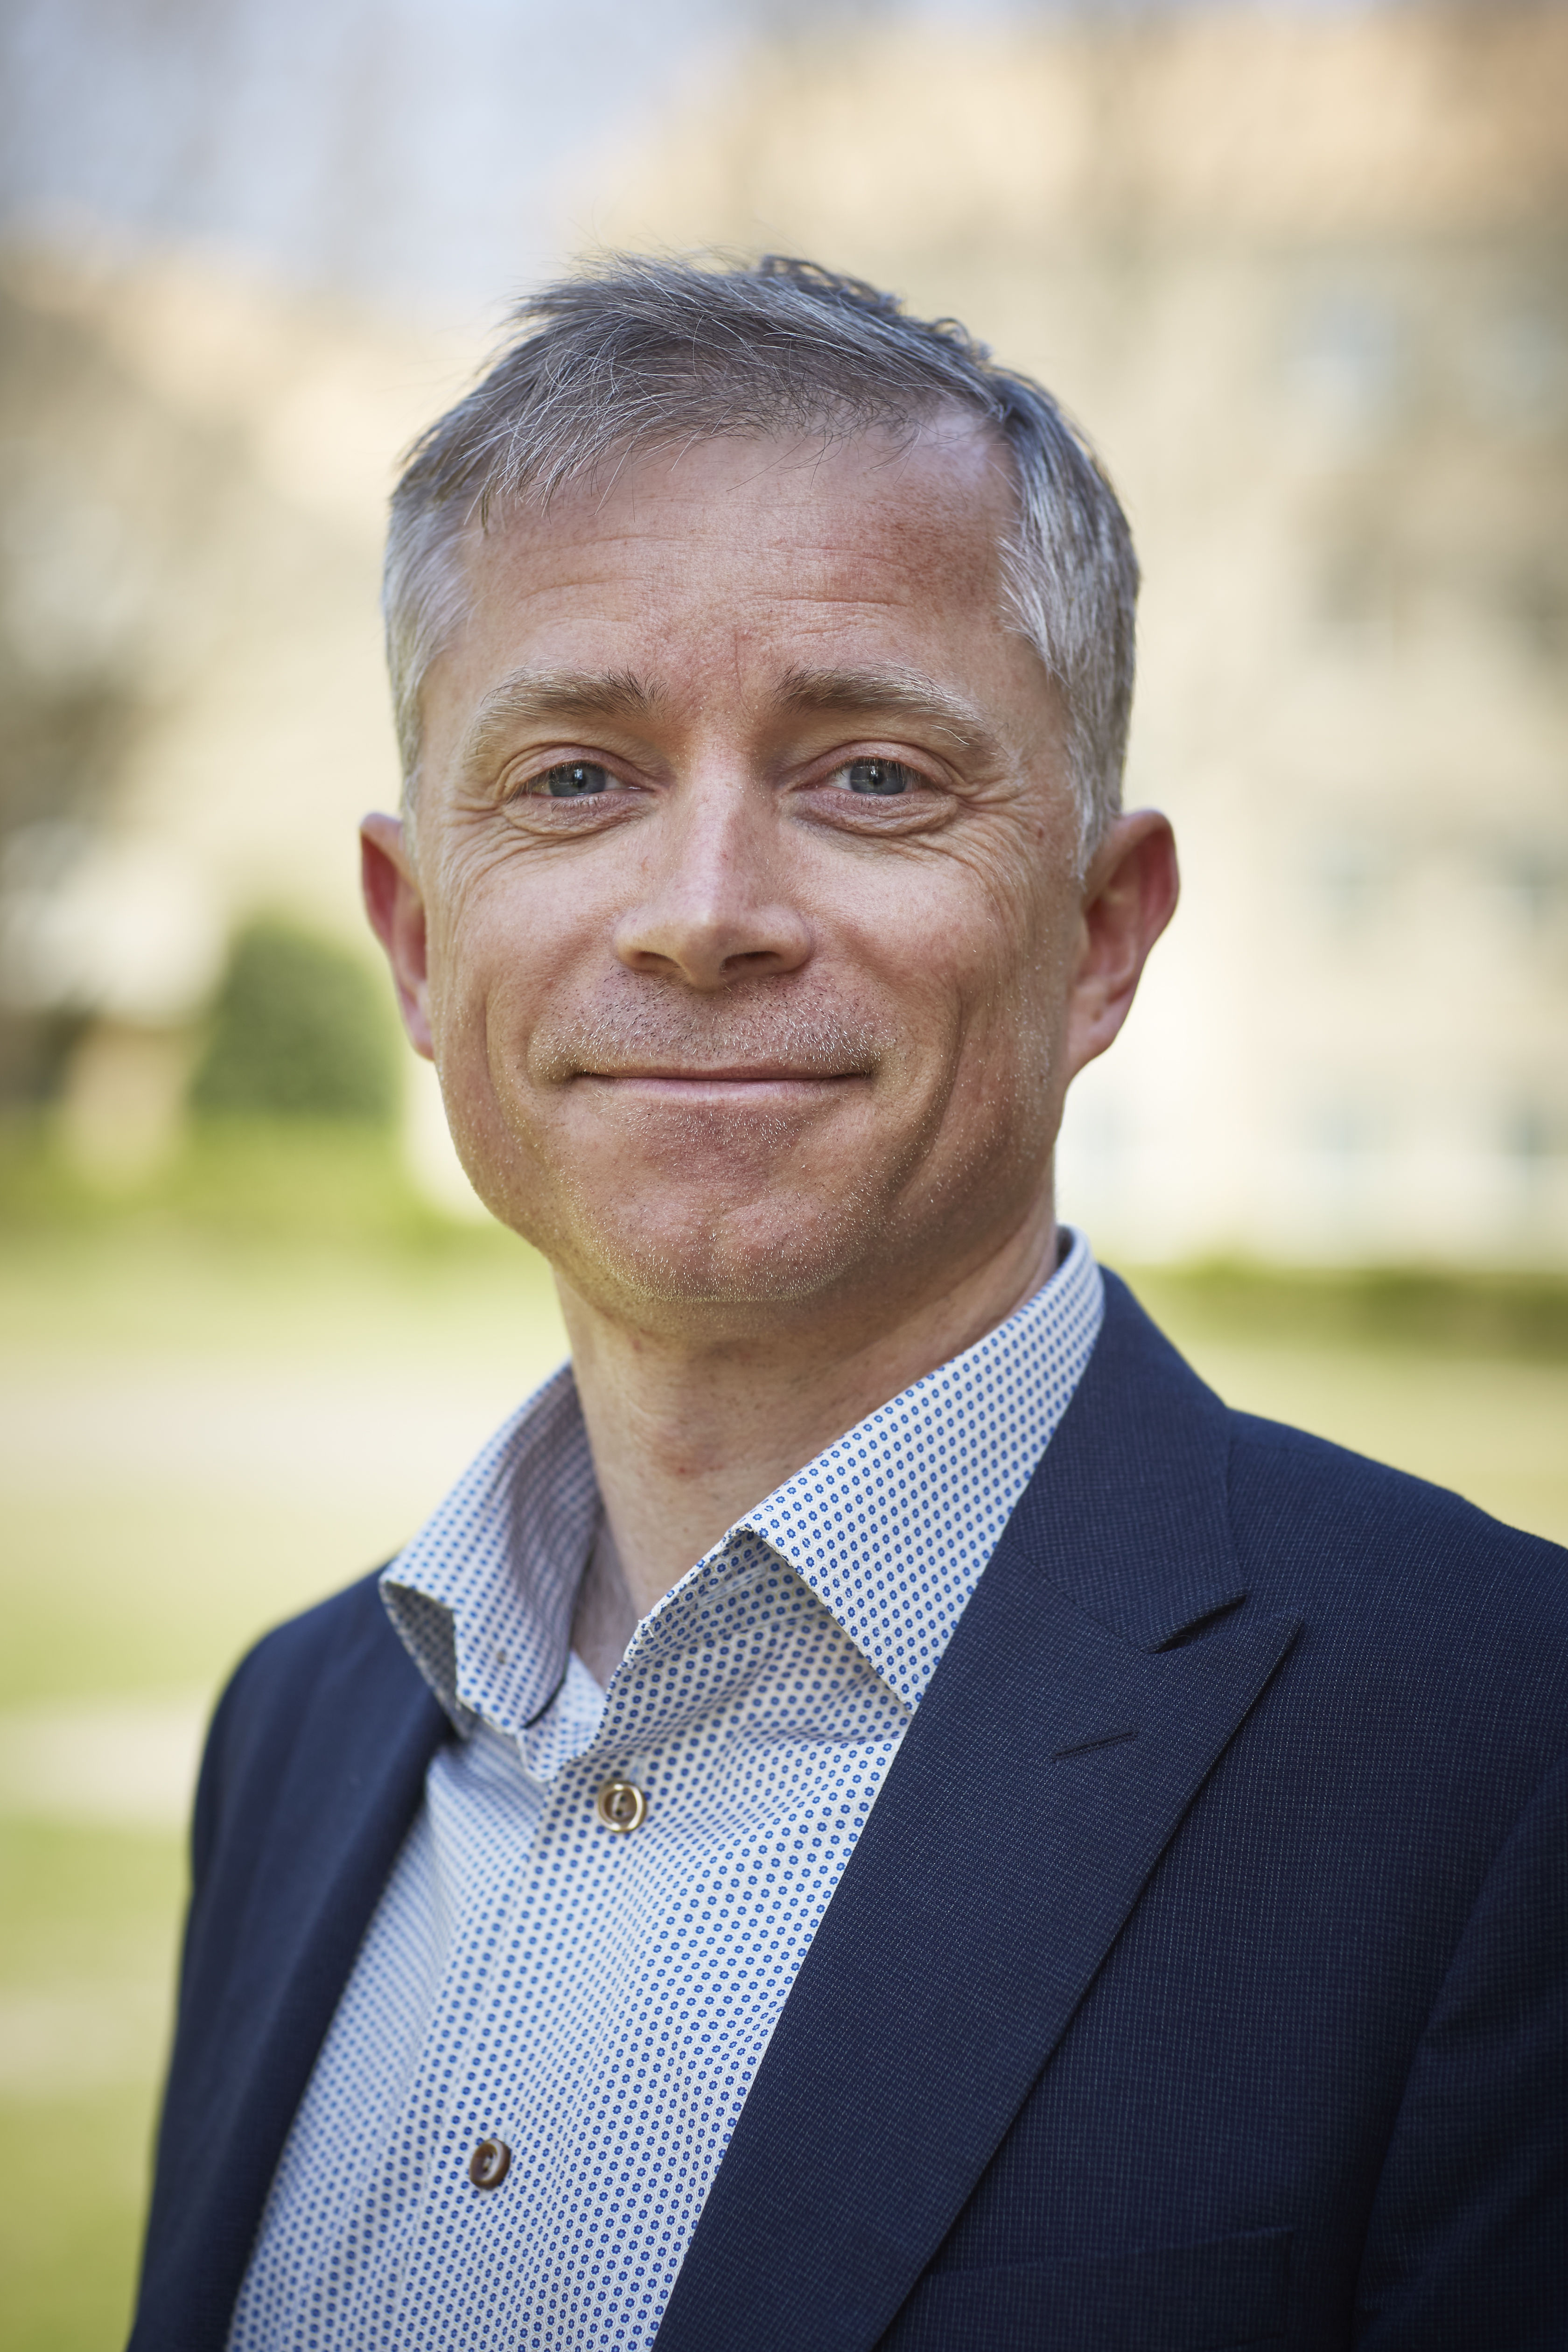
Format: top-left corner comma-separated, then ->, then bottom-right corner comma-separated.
231,1235 -> 1103,2352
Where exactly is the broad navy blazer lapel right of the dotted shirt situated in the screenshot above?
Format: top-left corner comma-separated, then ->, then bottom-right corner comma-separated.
658,1277 -> 1298,2352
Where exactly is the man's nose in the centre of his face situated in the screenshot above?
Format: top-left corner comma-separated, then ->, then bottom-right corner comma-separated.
614,778 -> 811,993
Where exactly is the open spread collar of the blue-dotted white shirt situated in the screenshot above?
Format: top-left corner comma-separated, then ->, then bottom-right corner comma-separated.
381,1232 -> 1105,1731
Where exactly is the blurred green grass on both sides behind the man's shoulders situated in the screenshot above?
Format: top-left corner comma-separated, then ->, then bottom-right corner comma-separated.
0,1127 -> 1568,2352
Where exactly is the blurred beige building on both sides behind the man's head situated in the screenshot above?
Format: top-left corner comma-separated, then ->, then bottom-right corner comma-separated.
0,0 -> 1568,1266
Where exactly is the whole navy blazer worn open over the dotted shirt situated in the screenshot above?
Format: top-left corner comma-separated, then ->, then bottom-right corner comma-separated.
132,1280 -> 1568,2352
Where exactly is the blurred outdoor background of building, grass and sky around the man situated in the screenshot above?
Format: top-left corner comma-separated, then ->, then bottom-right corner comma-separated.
0,0 -> 1568,2352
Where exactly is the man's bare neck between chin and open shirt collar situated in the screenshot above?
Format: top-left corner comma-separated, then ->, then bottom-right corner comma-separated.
560,1190 -> 1056,1646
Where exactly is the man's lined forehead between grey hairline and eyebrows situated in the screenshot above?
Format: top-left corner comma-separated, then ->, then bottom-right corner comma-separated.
444,419 -> 1015,685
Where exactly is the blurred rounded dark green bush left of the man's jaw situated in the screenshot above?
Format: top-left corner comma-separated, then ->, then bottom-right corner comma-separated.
190,915 -> 399,1127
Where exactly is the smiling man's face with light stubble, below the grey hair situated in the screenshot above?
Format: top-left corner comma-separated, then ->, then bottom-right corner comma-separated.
369,423 -> 1166,1331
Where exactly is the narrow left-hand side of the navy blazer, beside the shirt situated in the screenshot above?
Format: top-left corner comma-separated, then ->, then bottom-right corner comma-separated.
132,1576 -> 451,2352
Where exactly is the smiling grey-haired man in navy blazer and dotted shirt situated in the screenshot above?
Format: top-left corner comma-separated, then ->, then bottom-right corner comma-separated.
134,261 -> 1568,2352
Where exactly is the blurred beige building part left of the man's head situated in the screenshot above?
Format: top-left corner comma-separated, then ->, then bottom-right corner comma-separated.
0,245 -> 468,1174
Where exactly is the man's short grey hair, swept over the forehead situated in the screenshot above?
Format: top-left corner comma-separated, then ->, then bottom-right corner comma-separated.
383,254 -> 1138,861
